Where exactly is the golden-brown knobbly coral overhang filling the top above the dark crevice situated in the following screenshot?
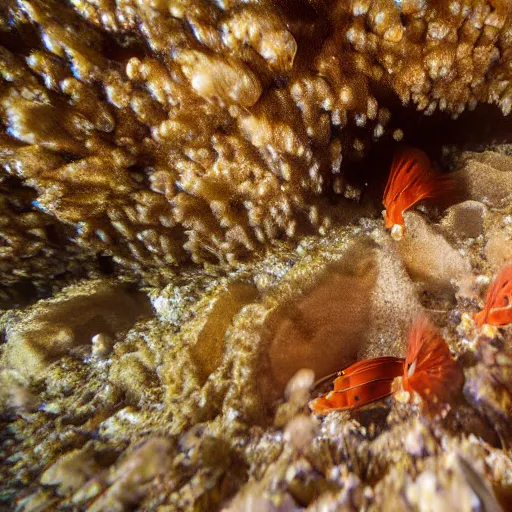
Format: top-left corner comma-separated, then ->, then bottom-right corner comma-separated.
0,0 -> 512,292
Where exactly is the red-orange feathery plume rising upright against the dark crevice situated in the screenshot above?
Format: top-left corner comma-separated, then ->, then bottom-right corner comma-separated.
382,148 -> 452,240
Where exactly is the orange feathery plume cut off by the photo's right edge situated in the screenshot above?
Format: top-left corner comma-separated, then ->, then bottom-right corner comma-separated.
473,263 -> 512,327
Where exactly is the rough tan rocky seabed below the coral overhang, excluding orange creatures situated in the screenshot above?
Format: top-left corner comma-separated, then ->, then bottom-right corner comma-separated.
0,146 -> 512,512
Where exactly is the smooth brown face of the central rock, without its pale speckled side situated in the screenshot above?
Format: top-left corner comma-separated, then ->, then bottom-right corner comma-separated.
267,241 -> 378,392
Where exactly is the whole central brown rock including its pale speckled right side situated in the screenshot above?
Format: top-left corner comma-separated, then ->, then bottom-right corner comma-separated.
267,237 -> 419,390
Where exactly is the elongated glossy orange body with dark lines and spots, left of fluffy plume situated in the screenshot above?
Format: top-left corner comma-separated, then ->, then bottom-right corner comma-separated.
309,357 -> 404,414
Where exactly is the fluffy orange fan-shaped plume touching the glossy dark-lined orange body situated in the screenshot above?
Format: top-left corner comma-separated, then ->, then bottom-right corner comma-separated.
402,316 -> 464,409
